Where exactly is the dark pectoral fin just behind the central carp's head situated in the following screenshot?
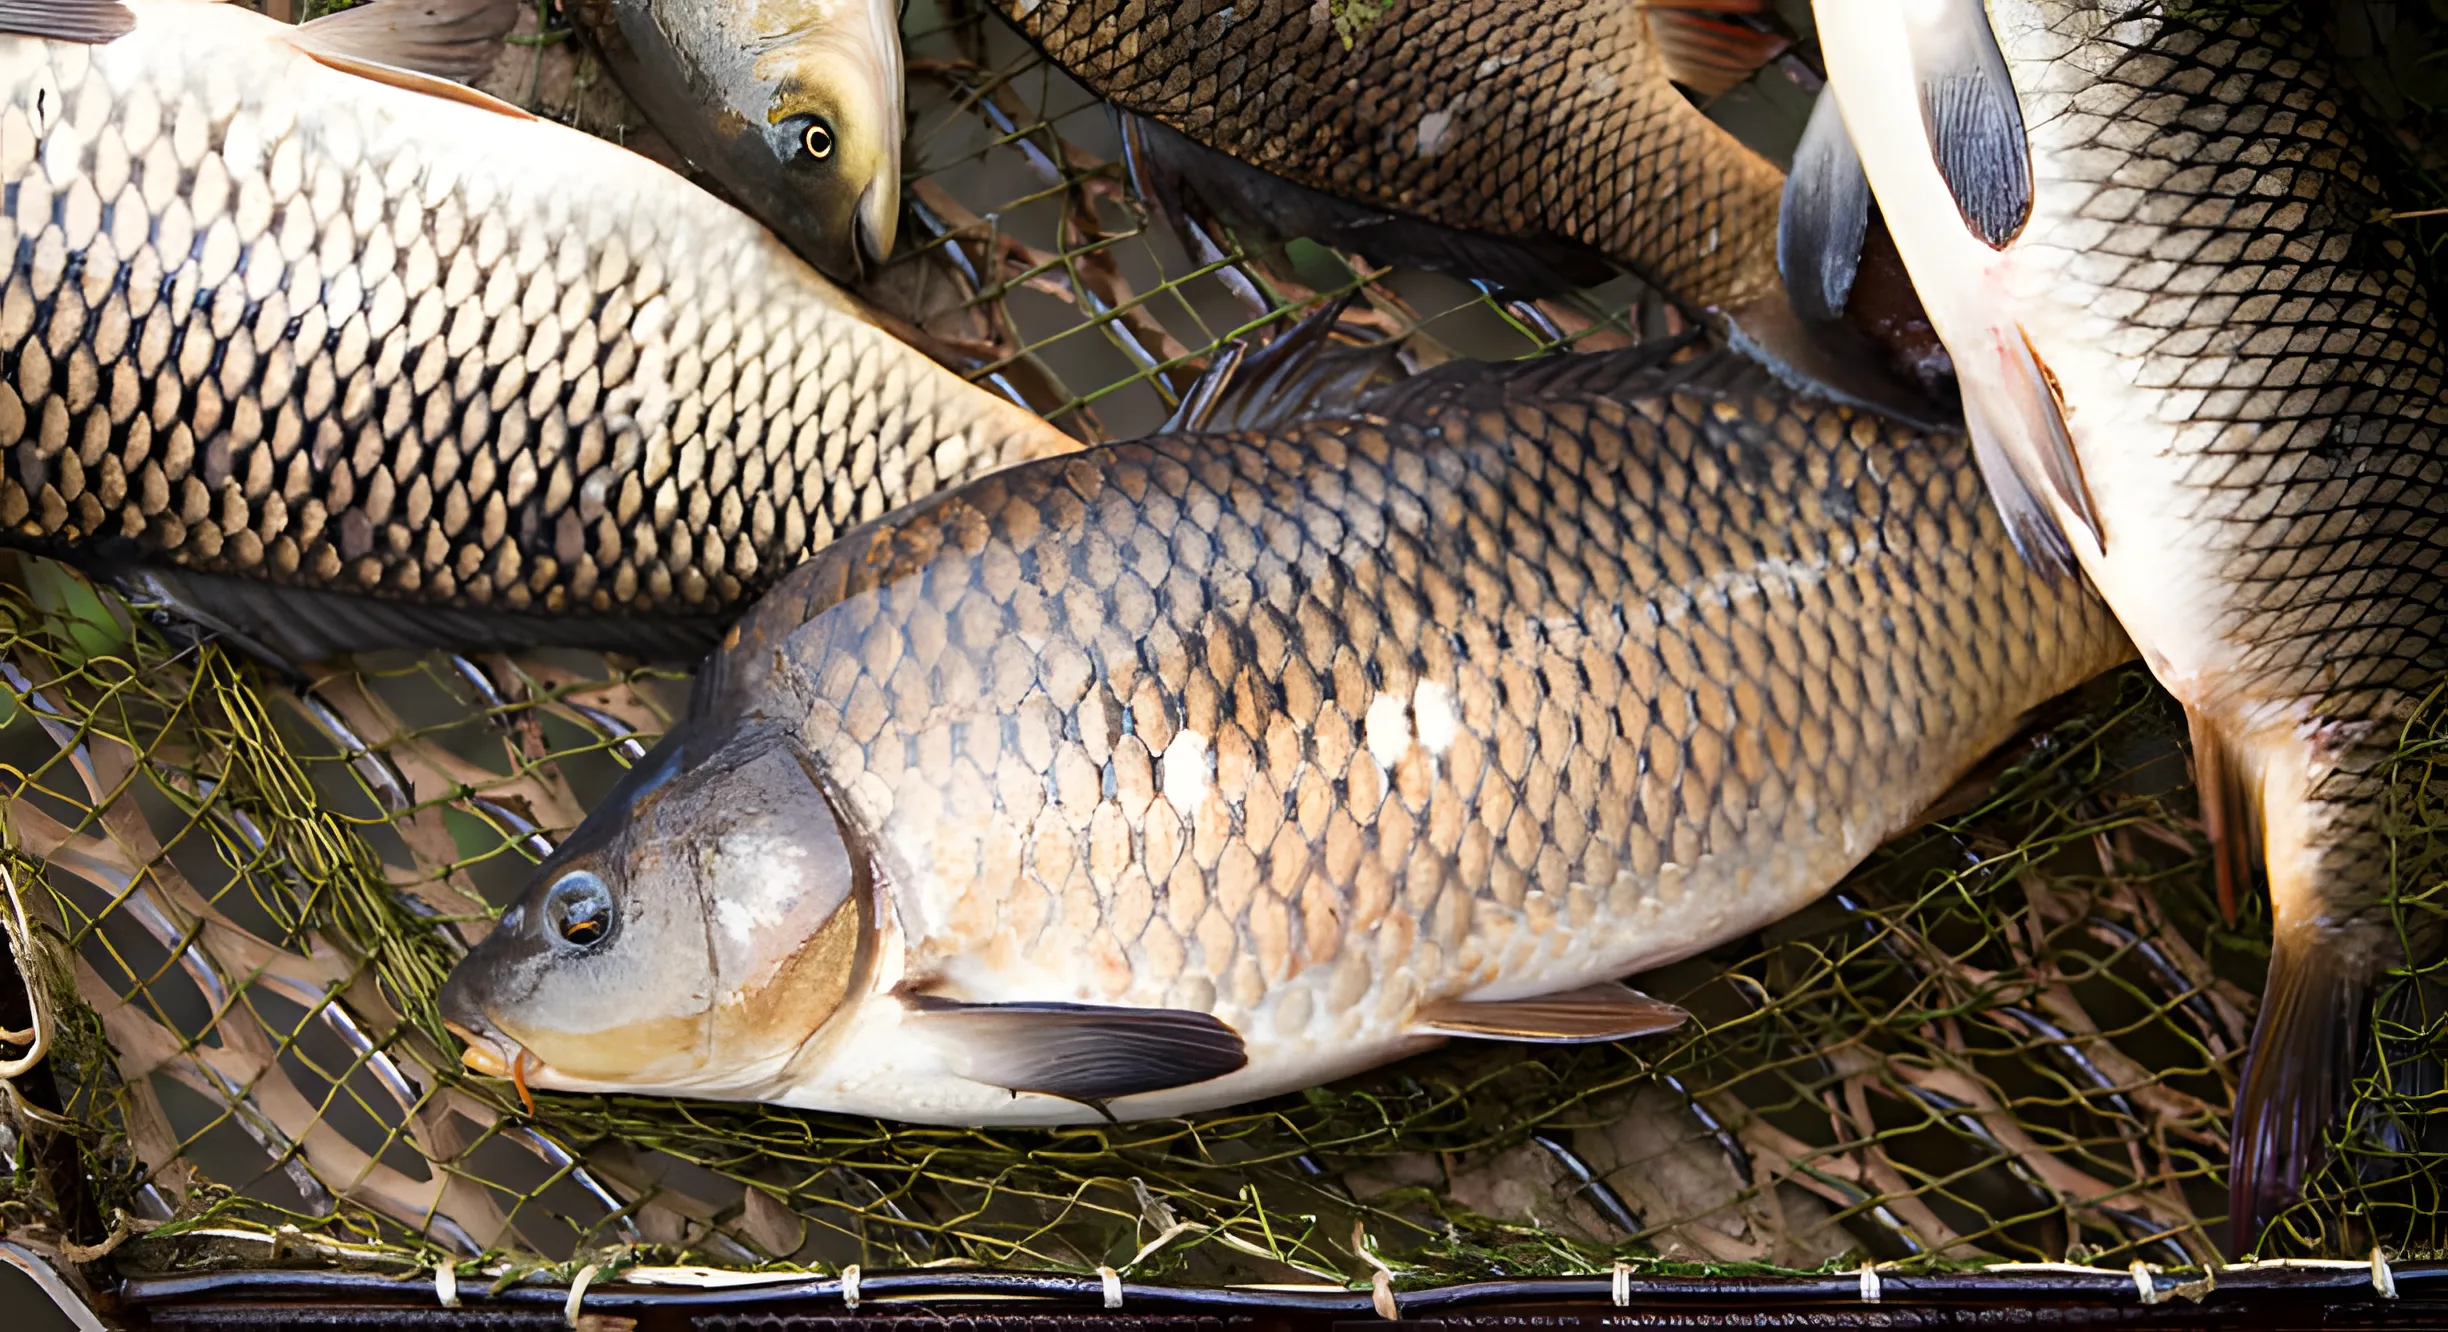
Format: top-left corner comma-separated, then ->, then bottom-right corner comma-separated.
908,994 -> 1248,1109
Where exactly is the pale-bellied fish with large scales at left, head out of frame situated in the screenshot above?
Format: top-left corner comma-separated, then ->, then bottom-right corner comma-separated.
0,0 -> 1077,661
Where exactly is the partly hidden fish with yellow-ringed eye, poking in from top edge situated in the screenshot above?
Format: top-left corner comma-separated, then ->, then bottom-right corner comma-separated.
568,0 -> 906,284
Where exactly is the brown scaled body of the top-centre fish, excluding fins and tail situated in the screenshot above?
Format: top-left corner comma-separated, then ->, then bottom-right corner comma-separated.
996,0 -> 1785,306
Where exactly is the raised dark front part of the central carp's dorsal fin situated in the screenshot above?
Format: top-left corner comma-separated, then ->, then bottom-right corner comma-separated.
1163,291 -> 1405,433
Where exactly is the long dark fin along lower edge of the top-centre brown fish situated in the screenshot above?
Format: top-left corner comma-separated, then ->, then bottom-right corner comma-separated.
1116,110 -> 1616,296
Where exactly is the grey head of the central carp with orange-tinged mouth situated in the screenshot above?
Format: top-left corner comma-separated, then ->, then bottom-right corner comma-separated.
441,737 -> 874,1099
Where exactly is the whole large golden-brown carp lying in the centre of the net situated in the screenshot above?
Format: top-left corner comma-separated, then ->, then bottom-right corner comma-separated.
438,345 -> 2132,1124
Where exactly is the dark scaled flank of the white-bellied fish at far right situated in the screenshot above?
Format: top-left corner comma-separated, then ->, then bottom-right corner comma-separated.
2000,5 -> 2448,852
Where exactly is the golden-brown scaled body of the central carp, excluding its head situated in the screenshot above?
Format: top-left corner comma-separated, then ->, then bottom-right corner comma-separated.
727,353 -> 2130,1090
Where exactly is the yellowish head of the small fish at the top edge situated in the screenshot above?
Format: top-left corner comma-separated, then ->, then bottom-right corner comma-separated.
742,0 -> 903,282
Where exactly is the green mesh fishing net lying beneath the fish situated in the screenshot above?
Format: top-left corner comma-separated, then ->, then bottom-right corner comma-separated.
0,5 -> 2448,1290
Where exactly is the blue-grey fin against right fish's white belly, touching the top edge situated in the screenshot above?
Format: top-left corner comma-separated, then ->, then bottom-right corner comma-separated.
1905,0 -> 2032,250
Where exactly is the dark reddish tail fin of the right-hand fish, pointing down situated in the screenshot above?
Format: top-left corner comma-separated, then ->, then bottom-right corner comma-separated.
2228,921 -> 2370,1254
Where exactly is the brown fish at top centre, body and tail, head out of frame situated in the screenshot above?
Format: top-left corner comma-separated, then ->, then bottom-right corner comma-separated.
994,0 -> 1954,426
